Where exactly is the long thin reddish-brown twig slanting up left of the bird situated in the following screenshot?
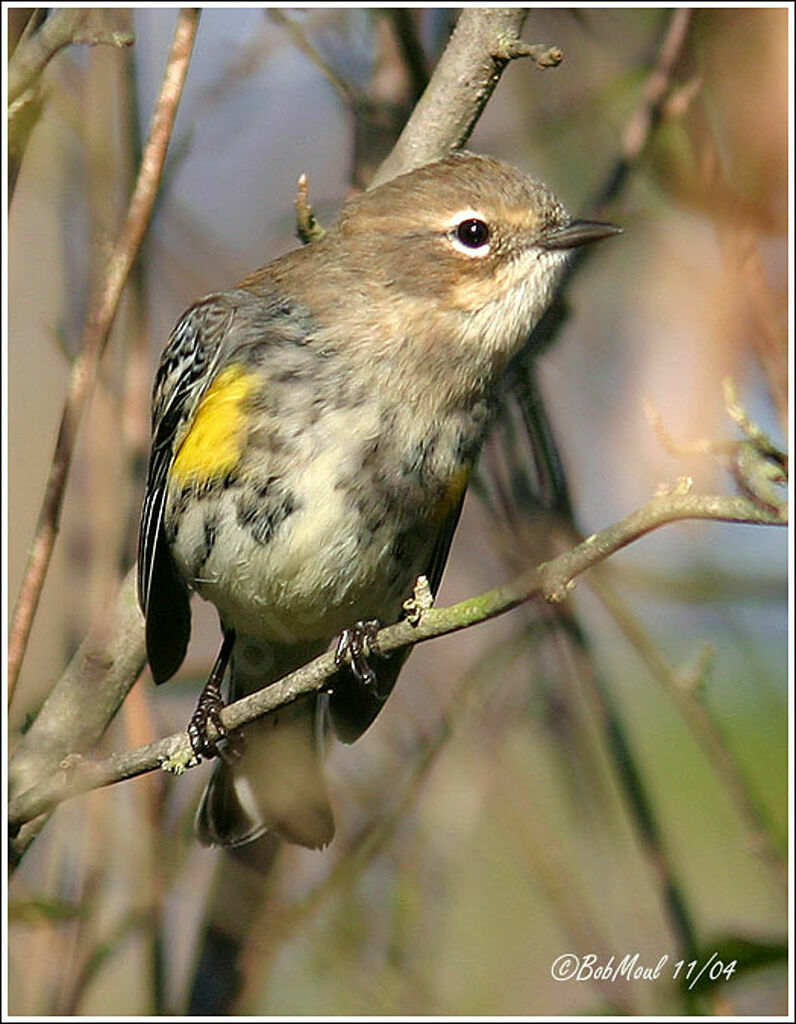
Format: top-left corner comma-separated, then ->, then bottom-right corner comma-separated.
8,8 -> 199,700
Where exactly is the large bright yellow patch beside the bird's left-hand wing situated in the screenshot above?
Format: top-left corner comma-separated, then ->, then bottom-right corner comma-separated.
171,366 -> 258,484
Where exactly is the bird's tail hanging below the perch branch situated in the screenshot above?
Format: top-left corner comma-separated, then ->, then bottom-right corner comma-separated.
196,640 -> 334,849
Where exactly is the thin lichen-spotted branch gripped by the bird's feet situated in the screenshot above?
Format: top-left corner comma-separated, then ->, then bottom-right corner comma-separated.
8,485 -> 786,835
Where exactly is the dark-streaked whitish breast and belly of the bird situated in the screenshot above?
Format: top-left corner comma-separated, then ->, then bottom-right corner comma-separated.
167,387 -> 484,643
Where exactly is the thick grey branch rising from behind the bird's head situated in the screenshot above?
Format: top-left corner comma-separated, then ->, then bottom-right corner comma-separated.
371,7 -> 563,187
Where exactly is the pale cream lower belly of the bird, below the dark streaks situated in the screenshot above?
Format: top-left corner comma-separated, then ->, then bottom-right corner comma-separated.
172,468 -> 432,643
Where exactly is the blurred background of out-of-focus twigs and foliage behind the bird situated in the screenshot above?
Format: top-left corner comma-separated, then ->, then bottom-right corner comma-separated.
8,7 -> 790,1017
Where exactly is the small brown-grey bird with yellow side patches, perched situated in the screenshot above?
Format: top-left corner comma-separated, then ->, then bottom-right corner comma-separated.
138,153 -> 619,847
